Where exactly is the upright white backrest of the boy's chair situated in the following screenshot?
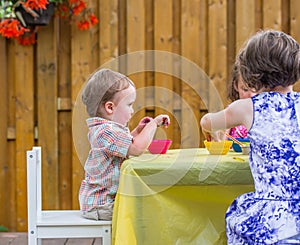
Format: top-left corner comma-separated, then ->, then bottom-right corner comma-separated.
27,147 -> 42,229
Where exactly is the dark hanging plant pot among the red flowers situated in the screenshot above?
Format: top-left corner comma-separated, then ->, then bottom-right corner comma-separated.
15,3 -> 55,26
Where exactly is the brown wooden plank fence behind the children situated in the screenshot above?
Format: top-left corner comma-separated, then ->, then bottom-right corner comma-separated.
0,0 -> 300,231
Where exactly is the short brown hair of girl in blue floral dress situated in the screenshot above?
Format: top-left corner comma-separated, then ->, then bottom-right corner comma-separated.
237,30 -> 300,91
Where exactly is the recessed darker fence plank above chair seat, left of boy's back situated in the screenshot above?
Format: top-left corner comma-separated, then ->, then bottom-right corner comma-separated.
57,18 -> 73,209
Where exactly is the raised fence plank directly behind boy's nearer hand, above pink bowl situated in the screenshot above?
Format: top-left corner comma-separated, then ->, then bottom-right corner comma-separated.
154,0 -> 174,139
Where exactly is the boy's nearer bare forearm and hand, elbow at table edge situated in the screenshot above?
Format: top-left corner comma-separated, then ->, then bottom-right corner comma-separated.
128,115 -> 170,156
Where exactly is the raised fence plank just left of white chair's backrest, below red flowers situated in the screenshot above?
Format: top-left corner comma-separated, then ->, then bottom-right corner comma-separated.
14,44 -> 34,231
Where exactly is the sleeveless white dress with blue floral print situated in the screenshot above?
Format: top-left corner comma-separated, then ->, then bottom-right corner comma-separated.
226,92 -> 300,245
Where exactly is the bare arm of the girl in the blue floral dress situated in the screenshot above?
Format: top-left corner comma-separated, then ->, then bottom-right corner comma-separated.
200,98 -> 253,140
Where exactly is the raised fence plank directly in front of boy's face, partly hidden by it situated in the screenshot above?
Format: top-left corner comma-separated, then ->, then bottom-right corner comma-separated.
126,0 -> 146,128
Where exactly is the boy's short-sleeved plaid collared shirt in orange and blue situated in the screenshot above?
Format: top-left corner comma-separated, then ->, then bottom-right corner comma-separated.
79,117 -> 132,211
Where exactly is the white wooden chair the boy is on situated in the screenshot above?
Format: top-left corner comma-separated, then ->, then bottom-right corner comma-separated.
27,147 -> 111,245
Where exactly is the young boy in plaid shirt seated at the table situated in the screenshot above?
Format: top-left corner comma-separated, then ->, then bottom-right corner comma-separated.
79,69 -> 170,220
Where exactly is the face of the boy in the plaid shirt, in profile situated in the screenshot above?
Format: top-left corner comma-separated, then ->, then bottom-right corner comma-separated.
112,85 -> 136,126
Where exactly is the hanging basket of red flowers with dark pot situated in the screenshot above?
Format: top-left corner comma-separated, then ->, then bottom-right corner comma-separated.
0,0 -> 98,45
